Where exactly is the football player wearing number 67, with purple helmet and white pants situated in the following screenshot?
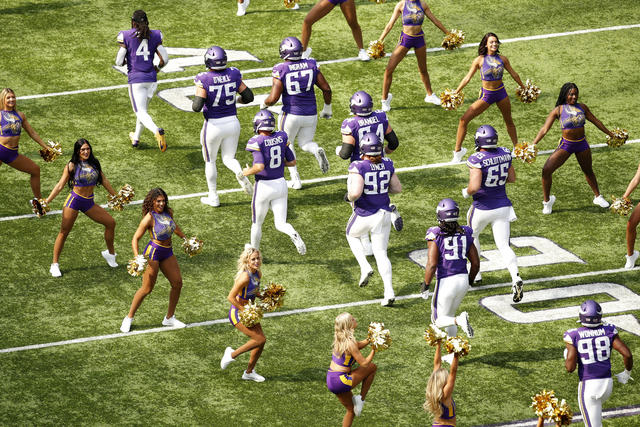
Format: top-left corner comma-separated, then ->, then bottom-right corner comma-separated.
260,37 -> 332,190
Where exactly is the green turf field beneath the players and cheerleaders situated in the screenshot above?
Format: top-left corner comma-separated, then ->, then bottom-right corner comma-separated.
0,0 -> 640,427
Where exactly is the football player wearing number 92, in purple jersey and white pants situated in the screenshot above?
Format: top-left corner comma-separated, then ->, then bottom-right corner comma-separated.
345,132 -> 402,307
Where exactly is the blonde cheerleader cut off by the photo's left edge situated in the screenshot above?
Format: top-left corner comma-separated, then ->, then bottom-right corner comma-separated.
0,87 -> 47,215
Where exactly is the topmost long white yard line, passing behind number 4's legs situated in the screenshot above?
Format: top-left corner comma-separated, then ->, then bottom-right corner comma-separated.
16,24 -> 640,100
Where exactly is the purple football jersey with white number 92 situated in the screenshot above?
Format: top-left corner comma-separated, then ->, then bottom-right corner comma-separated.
349,157 -> 395,216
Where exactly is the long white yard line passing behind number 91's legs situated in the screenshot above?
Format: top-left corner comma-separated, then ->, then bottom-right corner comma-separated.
0,267 -> 640,353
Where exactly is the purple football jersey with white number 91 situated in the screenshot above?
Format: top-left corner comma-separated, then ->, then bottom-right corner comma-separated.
425,225 -> 473,279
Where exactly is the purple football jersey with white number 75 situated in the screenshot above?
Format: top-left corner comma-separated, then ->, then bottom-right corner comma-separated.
193,67 -> 242,119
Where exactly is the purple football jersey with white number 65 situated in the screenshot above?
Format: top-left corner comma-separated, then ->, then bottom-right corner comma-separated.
467,147 -> 511,210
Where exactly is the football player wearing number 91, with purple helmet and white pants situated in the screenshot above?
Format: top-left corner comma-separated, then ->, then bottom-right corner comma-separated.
422,199 -> 480,352
